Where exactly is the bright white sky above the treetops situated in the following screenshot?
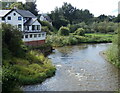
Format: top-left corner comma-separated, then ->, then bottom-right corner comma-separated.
19,0 -> 120,16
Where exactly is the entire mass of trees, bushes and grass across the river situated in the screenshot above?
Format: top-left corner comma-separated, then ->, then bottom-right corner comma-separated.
43,3 -> 119,46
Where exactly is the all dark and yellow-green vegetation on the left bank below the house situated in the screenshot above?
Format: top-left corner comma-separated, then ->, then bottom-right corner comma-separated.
1,24 -> 55,93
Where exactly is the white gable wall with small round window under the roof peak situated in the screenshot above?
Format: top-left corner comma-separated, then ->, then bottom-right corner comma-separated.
5,11 -> 24,31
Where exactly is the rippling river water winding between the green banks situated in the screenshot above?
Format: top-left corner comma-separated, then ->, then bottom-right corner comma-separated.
23,44 -> 118,91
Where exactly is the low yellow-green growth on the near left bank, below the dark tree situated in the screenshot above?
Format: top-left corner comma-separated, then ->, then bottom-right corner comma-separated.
3,51 -> 55,91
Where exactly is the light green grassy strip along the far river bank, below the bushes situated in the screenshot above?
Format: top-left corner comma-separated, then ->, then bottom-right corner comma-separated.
47,34 -> 113,47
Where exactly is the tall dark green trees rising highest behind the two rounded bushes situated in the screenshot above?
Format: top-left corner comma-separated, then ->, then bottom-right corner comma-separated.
50,3 -> 93,29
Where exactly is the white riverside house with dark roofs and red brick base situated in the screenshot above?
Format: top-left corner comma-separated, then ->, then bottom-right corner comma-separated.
0,9 -> 46,45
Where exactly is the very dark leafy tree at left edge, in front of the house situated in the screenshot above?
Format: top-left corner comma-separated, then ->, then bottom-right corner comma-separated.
2,24 -> 25,59
